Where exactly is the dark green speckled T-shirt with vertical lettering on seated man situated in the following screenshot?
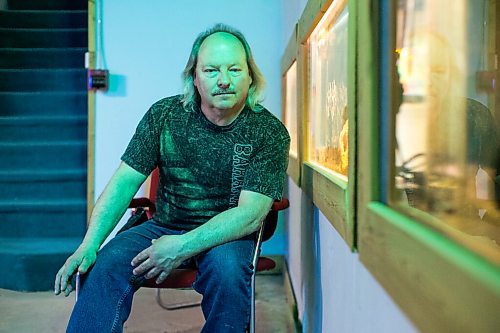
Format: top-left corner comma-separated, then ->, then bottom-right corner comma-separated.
122,95 -> 290,230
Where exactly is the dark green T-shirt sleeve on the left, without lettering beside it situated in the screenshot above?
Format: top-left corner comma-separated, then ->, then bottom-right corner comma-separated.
121,106 -> 160,176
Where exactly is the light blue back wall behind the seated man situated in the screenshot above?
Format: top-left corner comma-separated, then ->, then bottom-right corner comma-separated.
95,0 -> 284,254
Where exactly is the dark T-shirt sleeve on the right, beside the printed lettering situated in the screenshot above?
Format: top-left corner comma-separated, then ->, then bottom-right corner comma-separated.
242,126 -> 290,200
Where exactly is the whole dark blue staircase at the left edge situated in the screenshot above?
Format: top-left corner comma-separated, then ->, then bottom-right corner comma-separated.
0,0 -> 87,291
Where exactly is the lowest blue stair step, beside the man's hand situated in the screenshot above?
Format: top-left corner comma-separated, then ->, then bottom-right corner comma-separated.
0,237 -> 82,291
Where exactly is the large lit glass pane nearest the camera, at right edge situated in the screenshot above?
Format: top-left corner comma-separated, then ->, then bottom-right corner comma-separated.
391,0 -> 500,264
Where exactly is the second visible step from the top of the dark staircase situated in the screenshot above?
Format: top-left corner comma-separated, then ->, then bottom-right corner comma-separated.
0,10 -> 88,29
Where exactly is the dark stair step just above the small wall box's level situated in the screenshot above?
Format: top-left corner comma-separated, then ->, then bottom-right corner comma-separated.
0,47 -> 87,69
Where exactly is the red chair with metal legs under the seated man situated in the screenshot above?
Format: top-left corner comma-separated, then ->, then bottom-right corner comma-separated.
76,169 -> 290,333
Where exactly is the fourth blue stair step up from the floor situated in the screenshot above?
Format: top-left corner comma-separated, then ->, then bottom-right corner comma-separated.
0,140 -> 87,171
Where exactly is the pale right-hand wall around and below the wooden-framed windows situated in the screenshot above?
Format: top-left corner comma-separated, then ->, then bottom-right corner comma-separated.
282,0 -> 417,333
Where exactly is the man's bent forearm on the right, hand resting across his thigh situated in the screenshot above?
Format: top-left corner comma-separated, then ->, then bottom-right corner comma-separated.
132,191 -> 273,283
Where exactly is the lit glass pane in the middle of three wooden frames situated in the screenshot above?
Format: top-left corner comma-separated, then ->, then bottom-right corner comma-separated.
307,1 -> 349,177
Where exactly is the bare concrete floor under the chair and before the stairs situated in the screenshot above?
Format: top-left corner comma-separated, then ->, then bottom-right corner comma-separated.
0,275 -> 296,333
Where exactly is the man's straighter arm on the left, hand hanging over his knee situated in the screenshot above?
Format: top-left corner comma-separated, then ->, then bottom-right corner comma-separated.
54,162 -> 147,296
